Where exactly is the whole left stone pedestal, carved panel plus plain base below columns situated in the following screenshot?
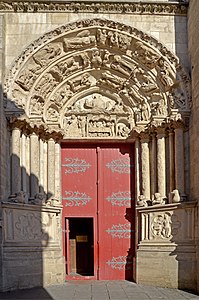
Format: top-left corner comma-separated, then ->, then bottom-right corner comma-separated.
2,203 -> 64,291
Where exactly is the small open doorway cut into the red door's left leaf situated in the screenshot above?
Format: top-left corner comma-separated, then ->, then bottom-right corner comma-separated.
65,218 -> 94,276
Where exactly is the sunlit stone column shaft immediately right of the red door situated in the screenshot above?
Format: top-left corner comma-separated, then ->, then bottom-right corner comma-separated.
141,138 -> 150,199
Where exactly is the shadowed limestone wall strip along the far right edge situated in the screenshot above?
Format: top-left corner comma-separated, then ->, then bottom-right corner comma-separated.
188,0 -> 199,290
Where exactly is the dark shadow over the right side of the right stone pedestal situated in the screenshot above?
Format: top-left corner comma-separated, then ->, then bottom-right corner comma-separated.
169,203 -> 197,291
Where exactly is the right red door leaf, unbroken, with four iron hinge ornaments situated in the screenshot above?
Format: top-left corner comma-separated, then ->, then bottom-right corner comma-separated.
98,145 -> 134,280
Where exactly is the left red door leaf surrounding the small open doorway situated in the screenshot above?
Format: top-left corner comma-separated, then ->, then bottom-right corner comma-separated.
62,146 -> 98,279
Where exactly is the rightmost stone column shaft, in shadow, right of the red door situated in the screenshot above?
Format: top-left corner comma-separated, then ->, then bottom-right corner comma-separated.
175,127 -> 185,196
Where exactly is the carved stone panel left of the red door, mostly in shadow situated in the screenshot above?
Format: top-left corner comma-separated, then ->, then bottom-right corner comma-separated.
1,202 -> 61,247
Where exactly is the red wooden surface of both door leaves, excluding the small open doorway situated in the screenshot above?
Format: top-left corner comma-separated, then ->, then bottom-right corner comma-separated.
62,144 -> 134,280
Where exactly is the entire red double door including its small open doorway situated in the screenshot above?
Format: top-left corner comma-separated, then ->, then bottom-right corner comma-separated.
62,144 -> 135,280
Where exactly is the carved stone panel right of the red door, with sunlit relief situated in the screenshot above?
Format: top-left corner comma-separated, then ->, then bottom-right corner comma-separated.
136,201 -> 197,246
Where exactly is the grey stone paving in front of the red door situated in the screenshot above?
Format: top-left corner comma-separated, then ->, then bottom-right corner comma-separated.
0,281 -> 199,300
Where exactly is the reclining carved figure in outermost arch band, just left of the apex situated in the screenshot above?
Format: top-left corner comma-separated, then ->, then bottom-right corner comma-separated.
63,30 -> 96,52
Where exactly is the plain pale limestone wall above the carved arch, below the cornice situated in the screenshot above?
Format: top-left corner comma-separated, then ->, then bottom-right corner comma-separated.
5,12 -> 189,73
